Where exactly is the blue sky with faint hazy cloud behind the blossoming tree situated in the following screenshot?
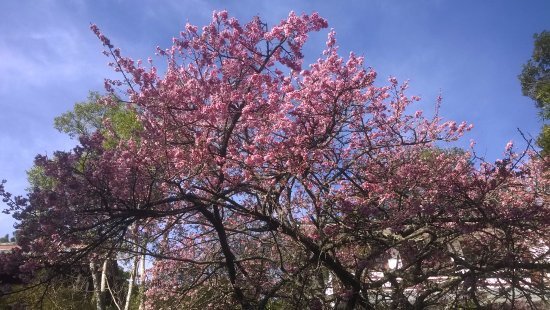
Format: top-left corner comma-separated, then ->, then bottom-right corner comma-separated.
0,0 -> 550,235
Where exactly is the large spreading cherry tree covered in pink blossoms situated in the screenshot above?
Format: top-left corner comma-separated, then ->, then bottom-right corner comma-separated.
3,11 -> 550,309
